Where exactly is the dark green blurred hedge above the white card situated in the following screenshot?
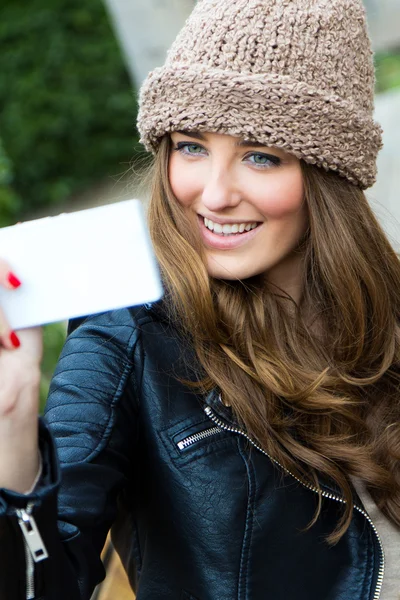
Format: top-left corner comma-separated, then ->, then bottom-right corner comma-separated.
0,0 -> 136,220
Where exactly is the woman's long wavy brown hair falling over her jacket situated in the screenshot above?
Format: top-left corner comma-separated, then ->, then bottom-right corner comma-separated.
149,136 -> 400,543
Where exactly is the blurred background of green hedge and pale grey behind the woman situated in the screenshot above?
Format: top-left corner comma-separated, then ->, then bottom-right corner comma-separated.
0,0 -> 400,600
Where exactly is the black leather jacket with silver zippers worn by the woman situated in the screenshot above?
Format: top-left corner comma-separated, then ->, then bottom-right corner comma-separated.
0,307 -> 383,600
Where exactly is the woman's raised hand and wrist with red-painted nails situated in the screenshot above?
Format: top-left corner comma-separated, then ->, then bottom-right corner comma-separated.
0,259 -> 42,493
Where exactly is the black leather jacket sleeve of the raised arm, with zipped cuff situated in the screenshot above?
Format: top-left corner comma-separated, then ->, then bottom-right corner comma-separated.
0,310 -> 143,600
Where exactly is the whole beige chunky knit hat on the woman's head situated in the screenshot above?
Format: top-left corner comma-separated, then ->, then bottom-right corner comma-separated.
138,0 -> 382,189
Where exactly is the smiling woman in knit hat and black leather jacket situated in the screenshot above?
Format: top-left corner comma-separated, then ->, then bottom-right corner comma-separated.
0,0 -> 400,600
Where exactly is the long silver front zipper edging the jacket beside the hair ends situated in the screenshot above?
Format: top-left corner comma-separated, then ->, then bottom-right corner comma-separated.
204,406 -> 385,600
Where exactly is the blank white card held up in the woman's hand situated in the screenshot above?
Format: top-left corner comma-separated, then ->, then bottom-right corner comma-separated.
0,200 -> 162,330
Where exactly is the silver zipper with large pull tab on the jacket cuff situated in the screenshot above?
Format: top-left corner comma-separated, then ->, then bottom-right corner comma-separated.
16,503 -> 49,600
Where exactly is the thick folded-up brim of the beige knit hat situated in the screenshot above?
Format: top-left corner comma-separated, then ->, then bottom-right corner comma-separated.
138,63 -> 382,189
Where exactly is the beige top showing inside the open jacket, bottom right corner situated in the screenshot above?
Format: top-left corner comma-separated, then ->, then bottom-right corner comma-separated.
353,480 -> 400,600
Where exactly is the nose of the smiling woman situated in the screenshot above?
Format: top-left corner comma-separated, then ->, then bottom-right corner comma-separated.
202,168 -> 241,212
